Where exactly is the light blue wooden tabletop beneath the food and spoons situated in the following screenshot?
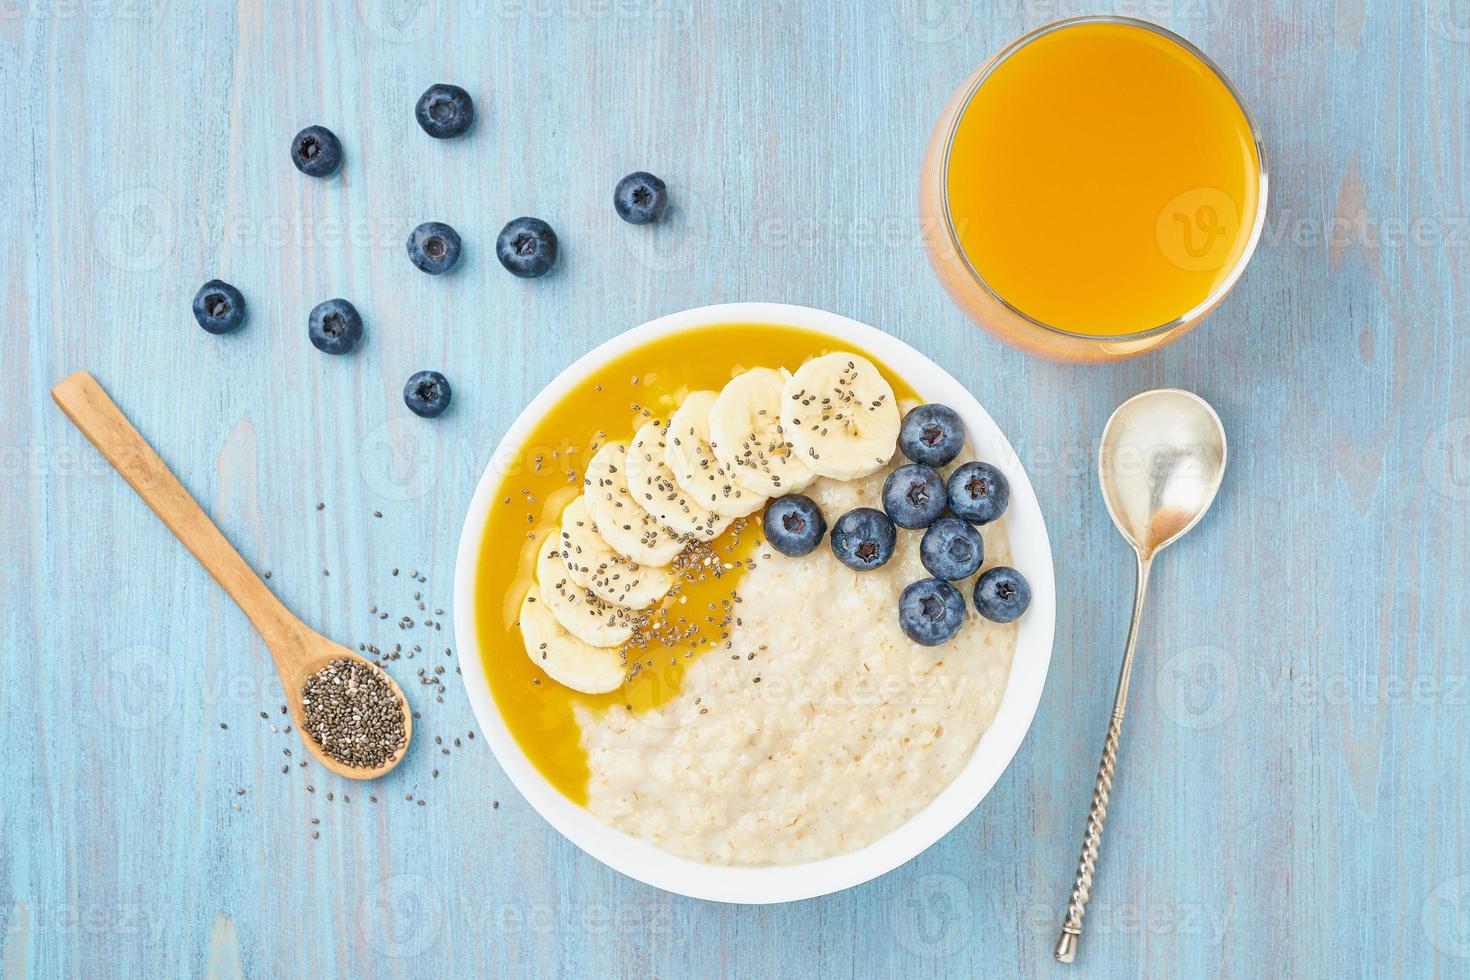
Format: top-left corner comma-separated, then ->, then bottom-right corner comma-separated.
0,0 -> 1470,980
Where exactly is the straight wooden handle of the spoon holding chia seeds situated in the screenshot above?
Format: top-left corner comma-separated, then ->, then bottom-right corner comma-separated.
51,370 -> 298,649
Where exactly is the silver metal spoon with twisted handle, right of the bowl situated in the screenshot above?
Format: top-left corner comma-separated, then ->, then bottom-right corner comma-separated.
1055,388 -> 1226,962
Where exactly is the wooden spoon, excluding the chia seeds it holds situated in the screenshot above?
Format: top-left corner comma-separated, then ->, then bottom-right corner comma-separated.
51,370 -> 413,779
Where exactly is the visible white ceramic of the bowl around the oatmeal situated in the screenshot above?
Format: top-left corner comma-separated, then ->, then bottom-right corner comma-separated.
454,303 -> 1057,904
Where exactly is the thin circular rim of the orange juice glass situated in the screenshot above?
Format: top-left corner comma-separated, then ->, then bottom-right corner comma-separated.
939,13 -> 1270,344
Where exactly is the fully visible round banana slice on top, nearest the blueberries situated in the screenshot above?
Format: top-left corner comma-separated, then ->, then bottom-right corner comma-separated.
781,353 -> 900,480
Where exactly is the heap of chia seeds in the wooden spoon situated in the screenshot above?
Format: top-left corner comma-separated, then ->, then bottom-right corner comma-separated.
301,658 -> 404,768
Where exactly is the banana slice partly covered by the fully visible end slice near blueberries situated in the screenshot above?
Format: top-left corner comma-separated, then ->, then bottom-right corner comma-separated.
710,367 -> 817,497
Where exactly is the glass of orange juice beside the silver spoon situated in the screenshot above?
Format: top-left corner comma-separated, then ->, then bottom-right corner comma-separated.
919,16 -> 1266,361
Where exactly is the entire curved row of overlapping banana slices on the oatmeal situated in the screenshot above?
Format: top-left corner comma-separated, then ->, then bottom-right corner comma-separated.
520,354 -> 900,693
